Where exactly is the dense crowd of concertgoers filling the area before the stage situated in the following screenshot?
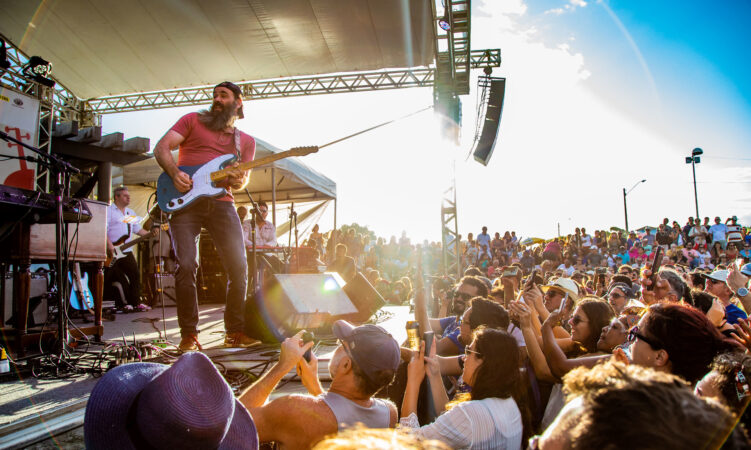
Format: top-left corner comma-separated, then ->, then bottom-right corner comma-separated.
85,214 -> 751,449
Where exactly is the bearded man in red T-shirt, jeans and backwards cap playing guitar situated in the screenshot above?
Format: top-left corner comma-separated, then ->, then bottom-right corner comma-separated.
154,81 -> 259,351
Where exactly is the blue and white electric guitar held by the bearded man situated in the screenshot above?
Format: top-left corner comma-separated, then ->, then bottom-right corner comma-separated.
156,146 -> 318,213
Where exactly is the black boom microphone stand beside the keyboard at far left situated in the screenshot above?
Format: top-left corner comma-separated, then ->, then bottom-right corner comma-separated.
0,131 -> 81,358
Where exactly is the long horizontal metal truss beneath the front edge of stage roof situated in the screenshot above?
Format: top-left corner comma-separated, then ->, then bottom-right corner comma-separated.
87,67 -> 435,114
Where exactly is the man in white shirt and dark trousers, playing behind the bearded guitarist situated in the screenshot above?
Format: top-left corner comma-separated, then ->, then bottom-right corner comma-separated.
105,186 -> 156,311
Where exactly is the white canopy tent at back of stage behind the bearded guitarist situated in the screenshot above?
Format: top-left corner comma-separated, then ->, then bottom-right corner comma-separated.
121,138 -> 336,243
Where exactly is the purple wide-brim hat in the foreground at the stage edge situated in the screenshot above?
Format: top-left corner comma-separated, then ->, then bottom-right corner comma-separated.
84,352 -> 258,450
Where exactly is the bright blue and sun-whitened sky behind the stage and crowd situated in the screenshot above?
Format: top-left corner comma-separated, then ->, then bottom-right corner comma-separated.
102,0 -> 751,242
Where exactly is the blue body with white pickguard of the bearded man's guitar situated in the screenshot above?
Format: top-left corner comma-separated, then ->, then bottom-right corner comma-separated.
156,154 -> 235,214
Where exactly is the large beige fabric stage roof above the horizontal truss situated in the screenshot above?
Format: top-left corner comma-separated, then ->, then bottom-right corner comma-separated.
0,0 -> 434,99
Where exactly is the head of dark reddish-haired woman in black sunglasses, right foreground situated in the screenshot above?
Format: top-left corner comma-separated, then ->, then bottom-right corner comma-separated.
628,303 -> 740,385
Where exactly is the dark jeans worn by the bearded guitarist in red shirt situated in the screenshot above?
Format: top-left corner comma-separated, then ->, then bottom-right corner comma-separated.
170,198 -> 248,336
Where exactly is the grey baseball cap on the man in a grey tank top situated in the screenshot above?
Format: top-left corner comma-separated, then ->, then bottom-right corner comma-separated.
333,320 -> 401,381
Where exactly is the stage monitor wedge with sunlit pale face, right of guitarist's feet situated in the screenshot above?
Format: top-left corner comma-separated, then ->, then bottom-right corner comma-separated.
245,273 -> 358,342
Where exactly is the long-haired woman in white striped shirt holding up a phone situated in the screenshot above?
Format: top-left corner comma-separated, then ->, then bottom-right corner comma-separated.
400,328 -> 530,450
